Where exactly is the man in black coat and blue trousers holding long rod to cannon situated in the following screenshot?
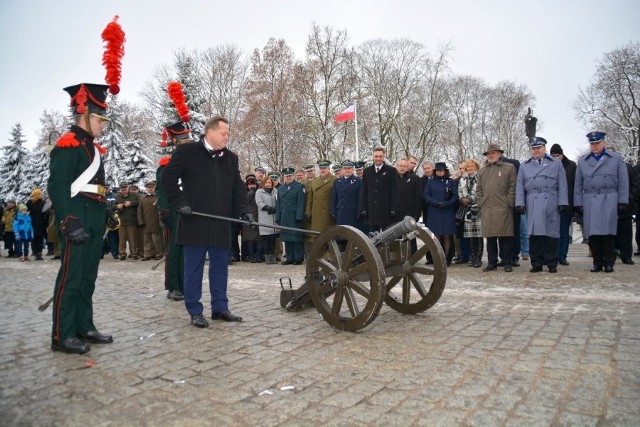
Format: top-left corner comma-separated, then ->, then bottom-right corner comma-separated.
162,116 -> 253,328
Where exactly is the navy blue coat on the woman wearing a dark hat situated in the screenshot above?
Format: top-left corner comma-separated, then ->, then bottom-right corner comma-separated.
424,176 -> 458,236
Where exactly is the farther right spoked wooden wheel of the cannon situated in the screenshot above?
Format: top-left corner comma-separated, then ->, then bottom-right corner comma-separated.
384,228 -> 447,314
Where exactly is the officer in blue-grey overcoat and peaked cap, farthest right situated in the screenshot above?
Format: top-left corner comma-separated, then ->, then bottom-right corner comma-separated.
573,132 -> 629,273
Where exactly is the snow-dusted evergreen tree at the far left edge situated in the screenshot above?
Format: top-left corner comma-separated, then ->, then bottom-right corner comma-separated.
0,123 -> 30,203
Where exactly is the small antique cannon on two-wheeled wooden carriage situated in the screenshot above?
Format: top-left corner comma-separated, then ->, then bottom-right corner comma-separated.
280,217 -> 447,332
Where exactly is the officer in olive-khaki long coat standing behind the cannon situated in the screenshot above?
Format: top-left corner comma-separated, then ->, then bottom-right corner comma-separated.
304,160 -> 336,241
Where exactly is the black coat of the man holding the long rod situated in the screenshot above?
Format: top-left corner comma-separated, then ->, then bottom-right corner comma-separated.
162,139 -> 251,248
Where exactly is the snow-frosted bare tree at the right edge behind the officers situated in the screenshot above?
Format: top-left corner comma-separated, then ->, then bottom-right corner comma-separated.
574,42 -> 640,161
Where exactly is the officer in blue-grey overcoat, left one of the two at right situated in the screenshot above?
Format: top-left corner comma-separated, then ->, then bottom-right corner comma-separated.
516,136 -> 569,273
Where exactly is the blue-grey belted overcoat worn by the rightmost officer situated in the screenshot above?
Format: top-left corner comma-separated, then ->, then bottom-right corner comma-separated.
573,150 -> 629,237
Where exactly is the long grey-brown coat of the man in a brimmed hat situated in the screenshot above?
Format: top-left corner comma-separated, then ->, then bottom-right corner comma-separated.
476,160 -> 516,237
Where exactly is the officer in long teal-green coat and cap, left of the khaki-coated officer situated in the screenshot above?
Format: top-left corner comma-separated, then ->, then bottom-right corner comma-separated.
276,167 -> 305,265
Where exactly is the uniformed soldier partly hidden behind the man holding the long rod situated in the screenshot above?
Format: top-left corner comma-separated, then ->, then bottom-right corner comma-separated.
156,121 -> 193,301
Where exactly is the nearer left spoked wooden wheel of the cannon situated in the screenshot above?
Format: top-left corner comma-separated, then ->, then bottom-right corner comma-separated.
306,225 -> 385,332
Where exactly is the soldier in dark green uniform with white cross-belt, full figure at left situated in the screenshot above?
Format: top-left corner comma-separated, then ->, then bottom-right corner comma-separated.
47,83 -> 113,354
